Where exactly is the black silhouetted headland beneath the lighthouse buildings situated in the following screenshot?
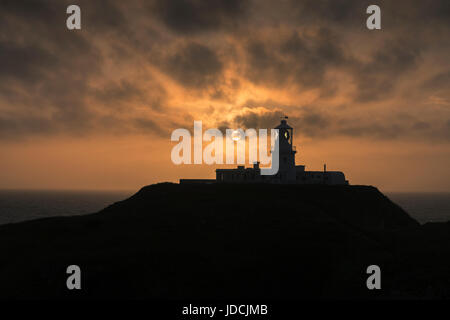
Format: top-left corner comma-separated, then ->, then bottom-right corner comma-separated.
0,183 -> 450,299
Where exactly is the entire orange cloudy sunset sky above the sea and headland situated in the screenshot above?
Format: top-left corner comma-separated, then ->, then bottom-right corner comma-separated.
0,0 -> 450,192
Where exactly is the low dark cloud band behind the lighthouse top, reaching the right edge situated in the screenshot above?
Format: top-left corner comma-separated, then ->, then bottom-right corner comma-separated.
227,106 -> 450,142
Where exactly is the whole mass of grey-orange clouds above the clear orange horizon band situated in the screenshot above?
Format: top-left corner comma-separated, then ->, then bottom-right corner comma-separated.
0,0 -> 450,141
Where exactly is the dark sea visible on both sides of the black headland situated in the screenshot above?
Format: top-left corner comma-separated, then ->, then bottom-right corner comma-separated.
0,190 -> 450,224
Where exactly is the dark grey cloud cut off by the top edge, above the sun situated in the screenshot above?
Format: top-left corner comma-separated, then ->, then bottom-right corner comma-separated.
151,0 -> 248,34
